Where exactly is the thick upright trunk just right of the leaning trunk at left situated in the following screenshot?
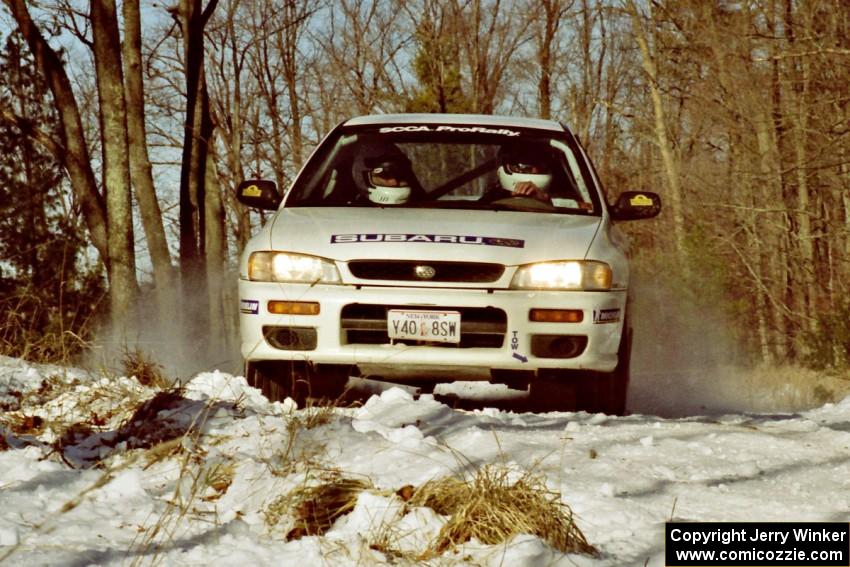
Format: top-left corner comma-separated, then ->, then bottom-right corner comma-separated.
91,0 -> 138,327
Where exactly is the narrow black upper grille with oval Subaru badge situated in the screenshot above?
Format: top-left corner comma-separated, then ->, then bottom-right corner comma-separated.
348,260 -> 505,283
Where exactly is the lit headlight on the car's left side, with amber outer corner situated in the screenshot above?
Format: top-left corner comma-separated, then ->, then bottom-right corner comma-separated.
248,252 -> 340,284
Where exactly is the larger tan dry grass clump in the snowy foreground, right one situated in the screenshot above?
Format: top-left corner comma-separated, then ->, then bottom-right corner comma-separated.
408,466 -> 597,556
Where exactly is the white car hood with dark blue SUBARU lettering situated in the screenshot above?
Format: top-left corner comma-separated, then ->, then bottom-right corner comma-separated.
249,207 -> 601,265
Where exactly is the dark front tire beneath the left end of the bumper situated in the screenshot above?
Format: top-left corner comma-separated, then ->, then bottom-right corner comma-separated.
245,360 -> 350,407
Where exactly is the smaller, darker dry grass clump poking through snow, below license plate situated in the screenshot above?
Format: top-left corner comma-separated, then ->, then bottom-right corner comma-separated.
266,476 -> 372,541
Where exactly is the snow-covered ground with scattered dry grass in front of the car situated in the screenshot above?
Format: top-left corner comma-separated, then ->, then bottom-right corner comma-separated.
0,358 -> 850,566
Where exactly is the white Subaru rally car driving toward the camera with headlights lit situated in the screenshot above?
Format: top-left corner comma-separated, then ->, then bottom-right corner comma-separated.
238,114 -> 661,413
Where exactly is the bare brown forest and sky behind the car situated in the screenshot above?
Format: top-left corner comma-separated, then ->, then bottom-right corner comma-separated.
0,0 -> 850,384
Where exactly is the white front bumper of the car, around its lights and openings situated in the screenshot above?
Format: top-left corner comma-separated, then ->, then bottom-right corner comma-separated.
239,280 -> 626,374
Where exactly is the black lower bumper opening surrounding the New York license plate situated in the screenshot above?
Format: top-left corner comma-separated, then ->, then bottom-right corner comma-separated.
341,303 -> 508,348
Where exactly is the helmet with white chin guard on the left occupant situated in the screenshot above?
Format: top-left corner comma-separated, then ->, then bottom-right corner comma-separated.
351,143 -> 413,205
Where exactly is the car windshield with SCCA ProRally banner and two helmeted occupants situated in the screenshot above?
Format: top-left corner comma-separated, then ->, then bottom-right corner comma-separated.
285,125 -> 600,215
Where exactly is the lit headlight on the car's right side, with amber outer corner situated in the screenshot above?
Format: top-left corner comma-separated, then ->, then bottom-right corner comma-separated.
511,260 -> 611,290
